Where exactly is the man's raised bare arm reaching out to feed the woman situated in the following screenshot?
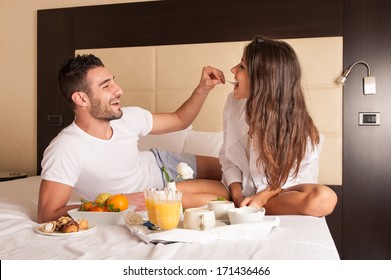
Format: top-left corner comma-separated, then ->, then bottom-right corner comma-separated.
151,66 -> 225,134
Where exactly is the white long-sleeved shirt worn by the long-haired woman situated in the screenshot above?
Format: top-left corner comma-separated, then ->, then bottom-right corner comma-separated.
219,93 -> 323,196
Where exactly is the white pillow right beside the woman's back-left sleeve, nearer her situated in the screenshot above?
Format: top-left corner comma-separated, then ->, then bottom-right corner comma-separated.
183,130 -> 223,157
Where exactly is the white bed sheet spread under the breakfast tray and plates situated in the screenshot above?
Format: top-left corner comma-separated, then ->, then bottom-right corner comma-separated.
0,176 -> 339,260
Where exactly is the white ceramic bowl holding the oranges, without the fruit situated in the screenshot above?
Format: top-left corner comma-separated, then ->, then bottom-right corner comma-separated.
68,205 -> 136,225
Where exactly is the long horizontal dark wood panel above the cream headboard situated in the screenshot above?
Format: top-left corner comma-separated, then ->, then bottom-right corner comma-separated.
70,0 -> 342,48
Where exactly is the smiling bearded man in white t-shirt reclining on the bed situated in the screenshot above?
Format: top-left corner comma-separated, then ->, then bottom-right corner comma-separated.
38,55 -> 225,223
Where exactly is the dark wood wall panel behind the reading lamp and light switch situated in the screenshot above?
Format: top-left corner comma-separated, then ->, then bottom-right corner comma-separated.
342,0 -> 391,259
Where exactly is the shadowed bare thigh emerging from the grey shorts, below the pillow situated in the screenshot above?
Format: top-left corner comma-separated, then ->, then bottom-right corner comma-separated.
196,155 -> 223,181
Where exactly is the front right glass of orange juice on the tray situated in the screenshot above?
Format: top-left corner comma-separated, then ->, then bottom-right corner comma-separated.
154,189 -> 182,230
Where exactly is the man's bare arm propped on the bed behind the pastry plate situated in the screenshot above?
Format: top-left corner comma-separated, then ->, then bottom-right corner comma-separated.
37,180 -> 80,223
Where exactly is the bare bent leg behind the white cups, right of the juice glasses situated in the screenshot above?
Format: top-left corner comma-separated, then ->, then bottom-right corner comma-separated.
177,179 -> 230,209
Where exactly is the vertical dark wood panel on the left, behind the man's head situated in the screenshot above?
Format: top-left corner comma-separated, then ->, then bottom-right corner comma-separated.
37,10 -> 74,170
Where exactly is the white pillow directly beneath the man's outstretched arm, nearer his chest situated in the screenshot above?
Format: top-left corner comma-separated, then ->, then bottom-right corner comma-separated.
138,126 -> 192,153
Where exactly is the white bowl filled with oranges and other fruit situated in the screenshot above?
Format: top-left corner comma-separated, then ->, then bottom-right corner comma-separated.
68,193 -> 136,225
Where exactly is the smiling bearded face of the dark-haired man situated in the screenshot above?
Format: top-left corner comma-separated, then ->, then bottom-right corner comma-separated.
87,67 -> 123,120
